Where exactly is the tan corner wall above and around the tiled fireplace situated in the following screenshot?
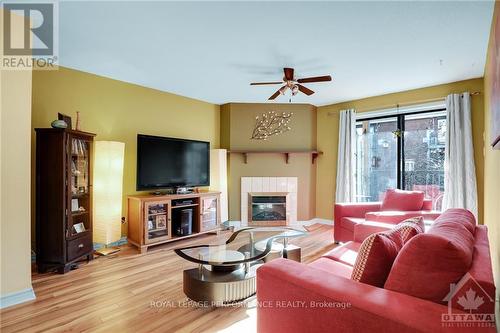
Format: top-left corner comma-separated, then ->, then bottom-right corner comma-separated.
221,103 -> 316,220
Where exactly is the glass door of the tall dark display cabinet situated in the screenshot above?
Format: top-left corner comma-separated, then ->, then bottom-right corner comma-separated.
68,137 -> 91,237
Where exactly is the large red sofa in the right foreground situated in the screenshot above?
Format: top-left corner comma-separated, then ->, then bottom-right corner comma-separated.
257,209 -> 495,333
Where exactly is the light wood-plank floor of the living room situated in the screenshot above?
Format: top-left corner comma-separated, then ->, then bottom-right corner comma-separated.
0,224 -> 335,333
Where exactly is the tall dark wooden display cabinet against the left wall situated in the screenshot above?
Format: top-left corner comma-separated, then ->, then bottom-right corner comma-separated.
35,128 -> 95,273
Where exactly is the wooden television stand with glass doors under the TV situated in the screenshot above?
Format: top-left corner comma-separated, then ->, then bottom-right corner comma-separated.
127,192 -> 221,253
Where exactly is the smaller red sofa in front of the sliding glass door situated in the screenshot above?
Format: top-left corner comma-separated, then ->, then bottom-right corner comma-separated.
333,189 -> 441,243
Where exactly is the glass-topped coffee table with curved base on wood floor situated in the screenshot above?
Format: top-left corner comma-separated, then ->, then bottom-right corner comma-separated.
174,227 -> 307,306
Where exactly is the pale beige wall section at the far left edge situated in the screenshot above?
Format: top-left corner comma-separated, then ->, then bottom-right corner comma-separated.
0,10 -> 31,297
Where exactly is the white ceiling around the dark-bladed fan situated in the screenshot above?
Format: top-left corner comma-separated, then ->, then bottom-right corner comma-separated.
59,1 -> 493,105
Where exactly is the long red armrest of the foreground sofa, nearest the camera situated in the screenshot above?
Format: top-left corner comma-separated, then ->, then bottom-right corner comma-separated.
257,259 -> 494,333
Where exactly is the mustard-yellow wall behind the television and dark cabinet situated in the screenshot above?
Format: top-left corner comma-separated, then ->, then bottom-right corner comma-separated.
33,67 -> 220,234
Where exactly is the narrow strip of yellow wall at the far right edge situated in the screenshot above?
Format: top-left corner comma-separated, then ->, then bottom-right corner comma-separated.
484,1 -> 500,299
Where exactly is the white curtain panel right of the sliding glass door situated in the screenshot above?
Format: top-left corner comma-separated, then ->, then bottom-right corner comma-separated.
443,92 -> 477,219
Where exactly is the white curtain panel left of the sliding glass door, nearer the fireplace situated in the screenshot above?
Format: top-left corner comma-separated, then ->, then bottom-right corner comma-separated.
335,109 -> 356,202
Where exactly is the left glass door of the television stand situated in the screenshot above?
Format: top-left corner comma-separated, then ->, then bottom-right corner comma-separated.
145,202 -> 170,243
